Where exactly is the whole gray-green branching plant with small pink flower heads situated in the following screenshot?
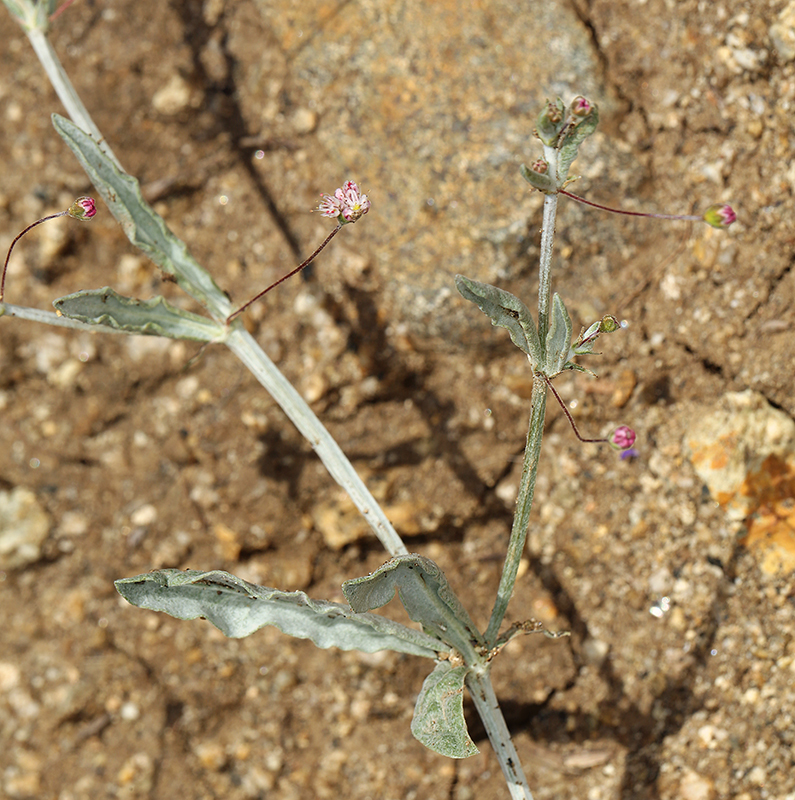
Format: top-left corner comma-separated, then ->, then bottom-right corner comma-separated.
0,0 -> 735,800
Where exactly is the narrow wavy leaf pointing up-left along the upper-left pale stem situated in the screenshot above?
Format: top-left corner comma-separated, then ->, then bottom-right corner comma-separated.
52,114 -> 232,319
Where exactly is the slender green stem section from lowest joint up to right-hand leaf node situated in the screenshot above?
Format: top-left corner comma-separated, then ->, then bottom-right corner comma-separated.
485,375 -> 547,647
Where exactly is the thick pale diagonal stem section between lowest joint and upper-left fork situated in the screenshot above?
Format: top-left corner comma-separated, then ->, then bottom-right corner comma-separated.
225,327 -> 408,556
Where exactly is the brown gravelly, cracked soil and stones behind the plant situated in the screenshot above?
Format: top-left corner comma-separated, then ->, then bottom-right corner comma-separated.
0,0 -> 795,800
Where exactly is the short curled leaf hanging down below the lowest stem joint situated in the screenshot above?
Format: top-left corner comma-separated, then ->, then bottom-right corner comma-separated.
411,661 -> 480,758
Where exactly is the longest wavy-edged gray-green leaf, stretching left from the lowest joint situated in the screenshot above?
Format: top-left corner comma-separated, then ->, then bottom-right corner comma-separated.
115,569 -> 444,658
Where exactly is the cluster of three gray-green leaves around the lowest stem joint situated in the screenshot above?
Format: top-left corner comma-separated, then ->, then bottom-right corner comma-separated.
115,555 -> 485,758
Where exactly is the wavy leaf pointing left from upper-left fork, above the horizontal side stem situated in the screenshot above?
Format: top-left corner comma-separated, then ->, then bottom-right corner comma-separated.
53,286 -> 226,342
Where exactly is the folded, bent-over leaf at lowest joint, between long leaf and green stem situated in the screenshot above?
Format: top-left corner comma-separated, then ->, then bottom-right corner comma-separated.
342,553 -> 484,664
